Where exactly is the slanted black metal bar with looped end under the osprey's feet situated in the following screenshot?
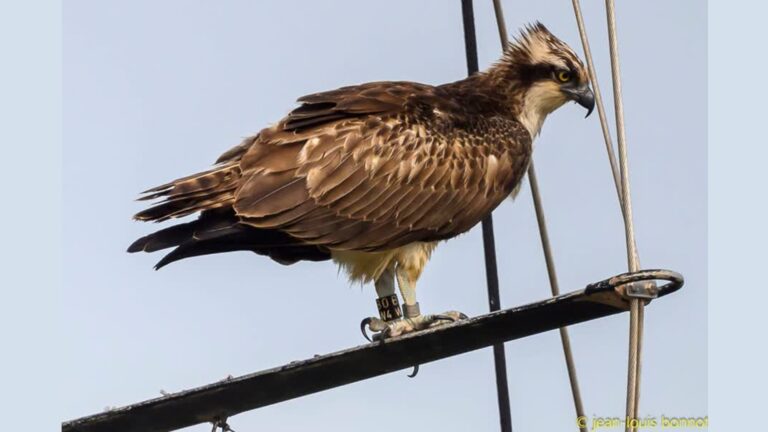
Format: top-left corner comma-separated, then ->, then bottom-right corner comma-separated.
62,270 -> 683,432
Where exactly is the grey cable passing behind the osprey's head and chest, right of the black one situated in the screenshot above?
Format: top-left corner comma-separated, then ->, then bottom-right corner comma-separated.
493,0 -> 587,432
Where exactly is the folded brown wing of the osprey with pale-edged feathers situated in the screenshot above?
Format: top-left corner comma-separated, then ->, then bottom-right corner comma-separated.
232,82 -> 531,250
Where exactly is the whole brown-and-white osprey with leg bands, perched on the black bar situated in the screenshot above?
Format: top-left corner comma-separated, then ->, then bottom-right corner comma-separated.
128,23 -> 594,337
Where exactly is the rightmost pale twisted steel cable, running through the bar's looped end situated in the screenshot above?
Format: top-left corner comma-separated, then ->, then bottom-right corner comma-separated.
605,0 -> 645,432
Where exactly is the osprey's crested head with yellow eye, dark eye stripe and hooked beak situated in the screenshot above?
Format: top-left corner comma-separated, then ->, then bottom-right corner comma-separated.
488,23 -> 595,136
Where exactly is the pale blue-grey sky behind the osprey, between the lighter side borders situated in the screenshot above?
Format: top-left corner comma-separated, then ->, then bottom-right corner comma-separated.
61,0 -> 707,431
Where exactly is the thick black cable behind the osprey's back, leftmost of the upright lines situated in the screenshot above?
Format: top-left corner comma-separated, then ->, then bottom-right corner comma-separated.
461,0 -> 512,432
